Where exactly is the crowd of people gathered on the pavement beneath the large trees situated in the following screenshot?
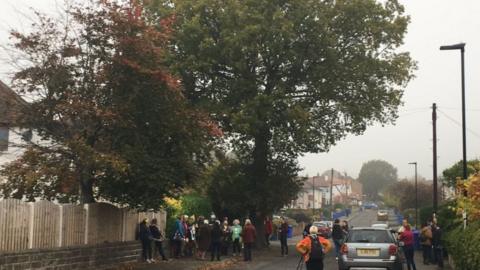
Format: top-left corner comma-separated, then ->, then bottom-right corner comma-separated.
138,215 -> 266,263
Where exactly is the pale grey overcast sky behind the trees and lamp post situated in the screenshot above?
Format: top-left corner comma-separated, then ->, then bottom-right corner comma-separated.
0,0 -> 480,179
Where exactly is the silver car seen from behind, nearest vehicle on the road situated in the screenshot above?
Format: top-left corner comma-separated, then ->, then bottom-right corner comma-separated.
338,227 -> 403,270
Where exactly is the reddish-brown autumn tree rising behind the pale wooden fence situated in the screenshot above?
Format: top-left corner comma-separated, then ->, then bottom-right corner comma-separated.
0,0 -> 214,208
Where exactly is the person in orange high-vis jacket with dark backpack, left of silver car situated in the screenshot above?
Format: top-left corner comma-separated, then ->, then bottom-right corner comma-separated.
297,226 -> 332,270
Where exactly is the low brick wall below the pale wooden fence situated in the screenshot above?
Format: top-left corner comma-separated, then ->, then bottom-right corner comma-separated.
0,241 -> 141,270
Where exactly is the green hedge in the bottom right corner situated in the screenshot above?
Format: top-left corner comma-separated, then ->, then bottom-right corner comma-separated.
445,221 -> 480,270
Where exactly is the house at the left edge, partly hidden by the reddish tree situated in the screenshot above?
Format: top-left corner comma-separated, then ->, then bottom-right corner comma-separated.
0,81 -> 31,166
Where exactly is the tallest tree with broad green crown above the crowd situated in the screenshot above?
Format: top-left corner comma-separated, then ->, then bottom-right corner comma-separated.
150,0 -> 414,243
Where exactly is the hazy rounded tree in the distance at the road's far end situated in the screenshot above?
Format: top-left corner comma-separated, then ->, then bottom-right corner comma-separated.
358,160 -> 398,199
